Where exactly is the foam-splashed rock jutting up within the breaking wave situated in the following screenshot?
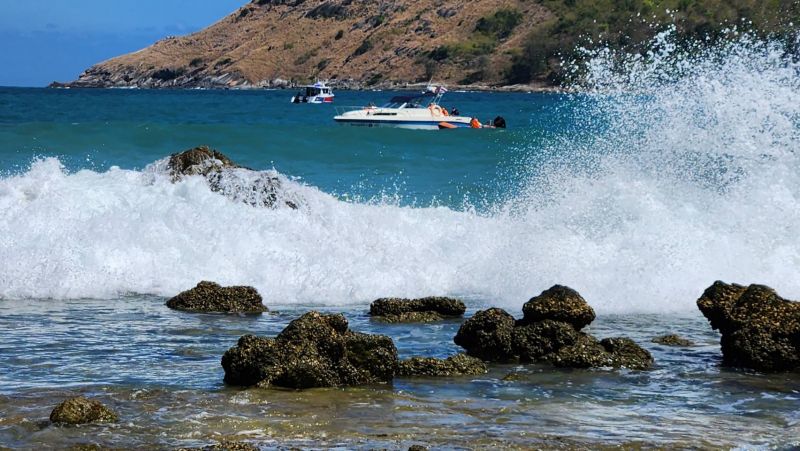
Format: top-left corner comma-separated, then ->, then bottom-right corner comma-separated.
167,146 -> 298,209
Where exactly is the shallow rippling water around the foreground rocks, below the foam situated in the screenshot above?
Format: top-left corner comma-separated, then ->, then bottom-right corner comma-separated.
0,297 -> 800,448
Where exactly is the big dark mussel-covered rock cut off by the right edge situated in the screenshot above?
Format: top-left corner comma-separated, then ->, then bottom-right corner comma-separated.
697,281 -> 800,371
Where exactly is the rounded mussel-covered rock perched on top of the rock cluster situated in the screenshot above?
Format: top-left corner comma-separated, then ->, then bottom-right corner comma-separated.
522,285 -> 595,330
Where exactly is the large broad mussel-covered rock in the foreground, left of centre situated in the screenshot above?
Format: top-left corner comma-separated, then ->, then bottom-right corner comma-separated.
222,311 -> 398,388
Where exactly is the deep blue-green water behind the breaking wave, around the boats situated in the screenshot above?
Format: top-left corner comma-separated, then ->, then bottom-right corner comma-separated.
0,88 -> 569,205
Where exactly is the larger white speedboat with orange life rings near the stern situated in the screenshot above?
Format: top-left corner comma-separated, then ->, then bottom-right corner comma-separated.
333,86 -> 480,130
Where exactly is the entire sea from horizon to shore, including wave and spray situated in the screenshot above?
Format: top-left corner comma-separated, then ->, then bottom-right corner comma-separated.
0,30 -> 800,449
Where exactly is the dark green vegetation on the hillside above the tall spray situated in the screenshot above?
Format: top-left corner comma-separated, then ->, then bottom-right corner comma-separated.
506,0 -> 800,84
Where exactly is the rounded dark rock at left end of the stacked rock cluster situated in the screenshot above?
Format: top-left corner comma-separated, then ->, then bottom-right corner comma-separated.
453,308 -> 518,362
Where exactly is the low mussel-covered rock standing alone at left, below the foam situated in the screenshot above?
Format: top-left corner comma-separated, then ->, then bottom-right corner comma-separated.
167,281 -> 267,313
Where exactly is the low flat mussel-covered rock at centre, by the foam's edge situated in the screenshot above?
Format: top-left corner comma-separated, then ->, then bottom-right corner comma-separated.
369,296 -> 467,323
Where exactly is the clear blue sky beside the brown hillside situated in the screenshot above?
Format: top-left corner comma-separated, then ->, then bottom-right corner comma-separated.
0,0 -> 248,86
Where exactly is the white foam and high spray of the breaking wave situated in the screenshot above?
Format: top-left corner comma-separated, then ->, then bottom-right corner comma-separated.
0,34 -> 800,313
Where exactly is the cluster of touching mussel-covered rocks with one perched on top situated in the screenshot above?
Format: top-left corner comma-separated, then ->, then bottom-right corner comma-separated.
454,285 -> 653,370
